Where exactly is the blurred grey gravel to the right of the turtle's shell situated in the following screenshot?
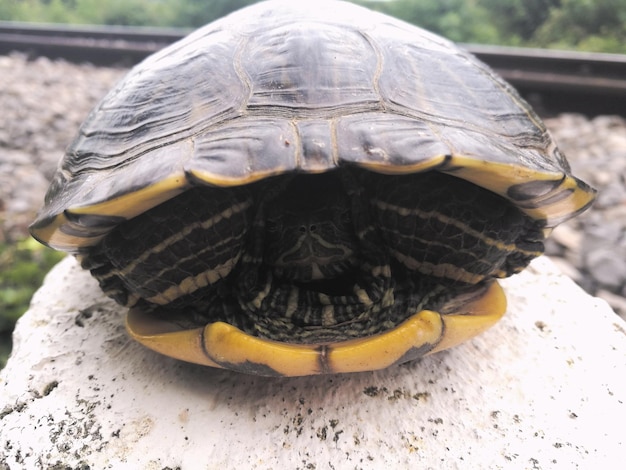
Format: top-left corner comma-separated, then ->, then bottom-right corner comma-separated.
545,114 -> 626,318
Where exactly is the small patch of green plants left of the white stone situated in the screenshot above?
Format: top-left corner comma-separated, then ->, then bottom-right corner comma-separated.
0,238 -> 63,368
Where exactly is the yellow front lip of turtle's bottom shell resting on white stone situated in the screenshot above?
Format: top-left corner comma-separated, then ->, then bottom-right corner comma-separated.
126,282 -> 506,376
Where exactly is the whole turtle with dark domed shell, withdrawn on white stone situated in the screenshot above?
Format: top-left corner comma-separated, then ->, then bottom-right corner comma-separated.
30,0 -> 595,376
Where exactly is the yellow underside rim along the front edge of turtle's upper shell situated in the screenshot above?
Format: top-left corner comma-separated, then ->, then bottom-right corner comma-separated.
31,155 -> 596,252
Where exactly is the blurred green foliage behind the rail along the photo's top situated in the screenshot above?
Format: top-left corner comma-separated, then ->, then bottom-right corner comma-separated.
0,0 -> 626,52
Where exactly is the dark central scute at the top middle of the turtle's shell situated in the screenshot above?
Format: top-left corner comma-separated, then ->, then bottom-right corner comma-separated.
240,22 -> 380,113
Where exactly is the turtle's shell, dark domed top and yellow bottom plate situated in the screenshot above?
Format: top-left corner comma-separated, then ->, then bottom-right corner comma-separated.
31,1 -> 595,375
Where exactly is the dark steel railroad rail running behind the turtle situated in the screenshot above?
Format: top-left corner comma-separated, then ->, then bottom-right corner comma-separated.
0,22 -> 626,116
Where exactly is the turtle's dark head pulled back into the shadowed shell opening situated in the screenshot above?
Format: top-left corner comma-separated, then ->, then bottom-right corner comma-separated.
265,175 -> 357,282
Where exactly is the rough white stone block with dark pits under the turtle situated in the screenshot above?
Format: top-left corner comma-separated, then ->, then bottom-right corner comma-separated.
0,258 -> 626,470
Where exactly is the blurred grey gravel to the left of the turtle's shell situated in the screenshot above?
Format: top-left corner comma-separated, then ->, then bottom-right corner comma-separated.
0,54 -> 126,242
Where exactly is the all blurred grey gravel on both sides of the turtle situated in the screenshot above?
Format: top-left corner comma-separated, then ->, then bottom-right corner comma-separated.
0,54 -> 626,318
